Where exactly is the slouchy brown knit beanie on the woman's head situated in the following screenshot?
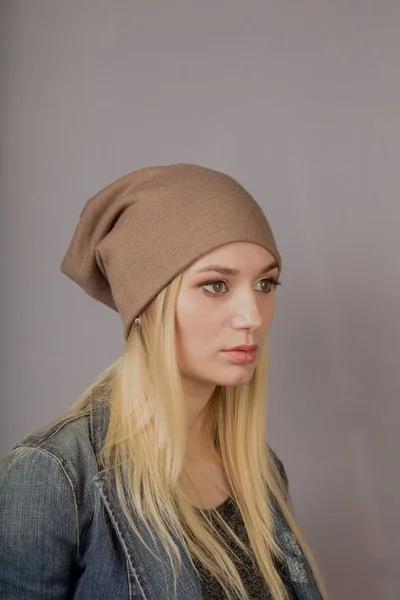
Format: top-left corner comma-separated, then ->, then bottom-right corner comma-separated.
61,164 -> 281,340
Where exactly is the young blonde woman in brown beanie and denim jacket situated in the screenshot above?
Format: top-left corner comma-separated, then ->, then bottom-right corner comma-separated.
0,164 -> 327,600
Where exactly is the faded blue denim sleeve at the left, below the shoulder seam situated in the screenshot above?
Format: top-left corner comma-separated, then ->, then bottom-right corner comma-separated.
0,447 -> 79,600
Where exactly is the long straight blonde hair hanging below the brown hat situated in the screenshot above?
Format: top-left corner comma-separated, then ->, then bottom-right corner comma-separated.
60,274 -> 328,600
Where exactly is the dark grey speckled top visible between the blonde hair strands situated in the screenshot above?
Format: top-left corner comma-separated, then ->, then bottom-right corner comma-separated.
193,497 -> 298,600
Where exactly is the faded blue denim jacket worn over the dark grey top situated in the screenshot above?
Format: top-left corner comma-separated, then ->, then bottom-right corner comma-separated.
0,399 -> 320,600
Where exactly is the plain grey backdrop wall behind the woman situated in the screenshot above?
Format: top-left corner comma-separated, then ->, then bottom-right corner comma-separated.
0,0 -> 400,600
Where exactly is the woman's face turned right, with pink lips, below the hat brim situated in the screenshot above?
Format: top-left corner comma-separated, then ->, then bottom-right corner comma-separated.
176,242 -> 278,386
